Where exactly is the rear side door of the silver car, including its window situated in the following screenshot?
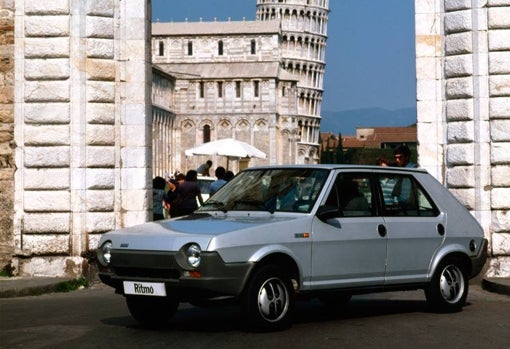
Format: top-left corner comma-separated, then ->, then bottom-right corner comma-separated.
375,173 -> 446,285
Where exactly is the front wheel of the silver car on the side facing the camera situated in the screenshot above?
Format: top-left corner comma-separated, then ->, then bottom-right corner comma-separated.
241,265 -> 294,331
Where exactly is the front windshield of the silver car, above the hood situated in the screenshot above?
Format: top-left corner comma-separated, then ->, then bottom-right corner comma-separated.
199,168 -> 329,213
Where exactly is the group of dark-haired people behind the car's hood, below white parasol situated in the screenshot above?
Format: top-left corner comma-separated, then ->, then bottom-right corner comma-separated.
152,160 -> 234,221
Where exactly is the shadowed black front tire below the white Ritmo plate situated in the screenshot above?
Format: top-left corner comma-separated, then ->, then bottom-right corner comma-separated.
126,296 -> 179,328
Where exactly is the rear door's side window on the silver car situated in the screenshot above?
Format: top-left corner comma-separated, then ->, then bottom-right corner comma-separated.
377,174 -> 439,217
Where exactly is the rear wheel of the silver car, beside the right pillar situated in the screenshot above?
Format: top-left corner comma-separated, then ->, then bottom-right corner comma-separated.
425,257 -> 469,312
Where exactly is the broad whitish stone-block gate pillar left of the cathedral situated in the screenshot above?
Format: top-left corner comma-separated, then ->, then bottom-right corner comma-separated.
2,0 -> 152,276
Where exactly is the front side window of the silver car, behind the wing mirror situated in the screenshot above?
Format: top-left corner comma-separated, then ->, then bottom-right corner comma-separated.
326,172 -> 374,217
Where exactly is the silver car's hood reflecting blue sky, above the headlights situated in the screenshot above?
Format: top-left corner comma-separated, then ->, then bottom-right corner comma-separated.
99,214 -> 297,251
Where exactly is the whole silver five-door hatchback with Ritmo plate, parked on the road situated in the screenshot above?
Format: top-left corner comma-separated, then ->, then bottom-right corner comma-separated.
97,165 -> 487,330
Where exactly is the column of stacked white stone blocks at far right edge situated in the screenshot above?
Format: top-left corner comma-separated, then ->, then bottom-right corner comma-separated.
483,0 -> 510,277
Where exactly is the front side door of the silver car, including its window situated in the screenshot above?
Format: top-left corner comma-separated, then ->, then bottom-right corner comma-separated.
310,172 -> 386,289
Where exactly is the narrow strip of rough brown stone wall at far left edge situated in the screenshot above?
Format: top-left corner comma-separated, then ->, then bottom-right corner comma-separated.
0,0 -> 14,272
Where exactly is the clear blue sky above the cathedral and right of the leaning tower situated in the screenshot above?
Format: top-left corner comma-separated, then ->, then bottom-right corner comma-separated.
152,0 -> 416,111
